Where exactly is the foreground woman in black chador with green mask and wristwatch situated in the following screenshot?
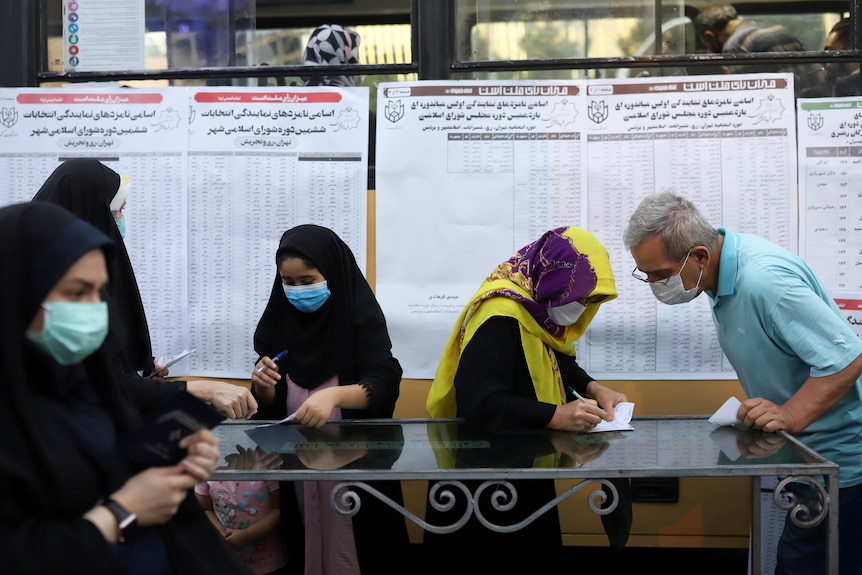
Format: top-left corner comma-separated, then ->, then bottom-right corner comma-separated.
0,203 -> 250,575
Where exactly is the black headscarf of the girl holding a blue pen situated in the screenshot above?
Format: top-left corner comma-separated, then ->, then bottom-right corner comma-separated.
254,224 -> 401,398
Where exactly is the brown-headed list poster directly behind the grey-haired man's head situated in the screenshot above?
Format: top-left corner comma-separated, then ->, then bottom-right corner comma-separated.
578,74 -> 798,379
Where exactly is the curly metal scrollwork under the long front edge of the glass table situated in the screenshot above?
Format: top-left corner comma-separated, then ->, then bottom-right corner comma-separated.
329,479 -> 619,533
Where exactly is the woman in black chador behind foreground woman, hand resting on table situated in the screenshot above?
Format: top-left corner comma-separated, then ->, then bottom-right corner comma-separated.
33,158 -> 257,419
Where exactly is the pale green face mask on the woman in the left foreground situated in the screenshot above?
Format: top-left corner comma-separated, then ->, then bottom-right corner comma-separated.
25,301 -> 108,365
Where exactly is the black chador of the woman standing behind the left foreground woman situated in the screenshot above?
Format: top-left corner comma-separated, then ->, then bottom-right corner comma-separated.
33,158 -> 153,374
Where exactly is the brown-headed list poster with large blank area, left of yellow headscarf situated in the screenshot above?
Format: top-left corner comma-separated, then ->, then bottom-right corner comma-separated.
376,81 -> 584,378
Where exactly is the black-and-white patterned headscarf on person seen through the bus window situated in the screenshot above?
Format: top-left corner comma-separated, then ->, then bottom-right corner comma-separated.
302,24 -> 362,86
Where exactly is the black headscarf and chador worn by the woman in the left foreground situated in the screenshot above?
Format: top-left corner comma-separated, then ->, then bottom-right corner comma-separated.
0,202 -> 252,575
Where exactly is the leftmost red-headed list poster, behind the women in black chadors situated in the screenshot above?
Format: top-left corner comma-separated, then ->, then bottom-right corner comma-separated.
0,86 -> 189,371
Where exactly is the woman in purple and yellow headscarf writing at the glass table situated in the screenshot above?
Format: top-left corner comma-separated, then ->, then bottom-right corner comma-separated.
426,227 -> 626,432
